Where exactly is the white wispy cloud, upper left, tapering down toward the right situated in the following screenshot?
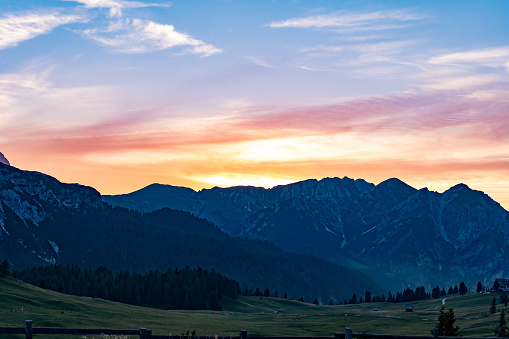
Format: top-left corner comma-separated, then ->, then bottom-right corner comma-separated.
82,19 -> 221,56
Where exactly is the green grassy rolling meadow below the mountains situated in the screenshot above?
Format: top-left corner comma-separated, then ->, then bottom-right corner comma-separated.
0,278 -> 503,339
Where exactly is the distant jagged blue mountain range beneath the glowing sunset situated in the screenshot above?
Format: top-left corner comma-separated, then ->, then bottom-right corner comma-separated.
103,177 -> 509,288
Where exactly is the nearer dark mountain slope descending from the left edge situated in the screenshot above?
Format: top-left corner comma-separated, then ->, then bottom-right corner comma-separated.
0,163 -> 383,302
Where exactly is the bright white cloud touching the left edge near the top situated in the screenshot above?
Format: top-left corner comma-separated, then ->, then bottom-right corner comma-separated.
0,11 -> 86,49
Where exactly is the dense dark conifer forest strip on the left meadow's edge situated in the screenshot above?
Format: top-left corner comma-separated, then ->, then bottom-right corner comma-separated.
13,264 -> 240,310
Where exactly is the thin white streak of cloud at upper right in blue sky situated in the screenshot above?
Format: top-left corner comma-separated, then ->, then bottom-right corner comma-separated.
267,10 -> 424,30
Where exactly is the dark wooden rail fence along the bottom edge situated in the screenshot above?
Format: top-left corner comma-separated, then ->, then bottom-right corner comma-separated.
0,320 -> 509,339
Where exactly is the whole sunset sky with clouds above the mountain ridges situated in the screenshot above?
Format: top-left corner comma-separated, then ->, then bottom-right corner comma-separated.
0,0 -> 509,209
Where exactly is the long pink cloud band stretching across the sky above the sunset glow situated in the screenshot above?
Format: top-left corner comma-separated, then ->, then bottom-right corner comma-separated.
2,82 -> 509,158
